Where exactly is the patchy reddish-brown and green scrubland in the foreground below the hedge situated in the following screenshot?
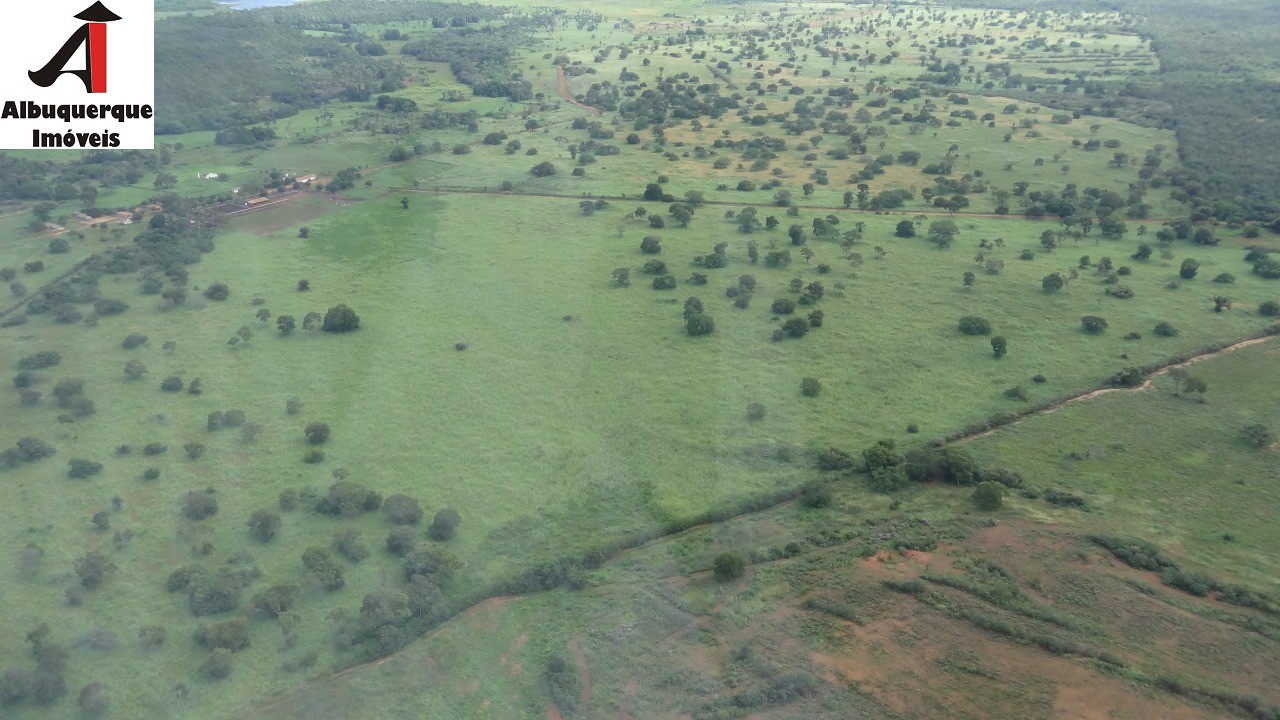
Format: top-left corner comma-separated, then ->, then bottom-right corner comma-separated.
241,520 -> 1280,720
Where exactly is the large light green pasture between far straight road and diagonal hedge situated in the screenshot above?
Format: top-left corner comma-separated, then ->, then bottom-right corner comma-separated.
0,188 -> 1275,714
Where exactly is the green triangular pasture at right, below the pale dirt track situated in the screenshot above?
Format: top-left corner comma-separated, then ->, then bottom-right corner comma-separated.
965,340 -> 1280,592
